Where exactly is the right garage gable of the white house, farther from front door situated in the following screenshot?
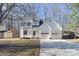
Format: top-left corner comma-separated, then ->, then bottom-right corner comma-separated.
48,19 -> 62,39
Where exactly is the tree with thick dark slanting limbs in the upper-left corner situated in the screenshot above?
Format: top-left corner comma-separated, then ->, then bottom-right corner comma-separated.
0,3 -> 15,24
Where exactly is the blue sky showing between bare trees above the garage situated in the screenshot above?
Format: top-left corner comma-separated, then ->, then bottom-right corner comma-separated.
34,3 -> 69,26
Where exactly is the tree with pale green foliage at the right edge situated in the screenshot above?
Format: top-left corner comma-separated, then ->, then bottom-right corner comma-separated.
64,4 -> 79,30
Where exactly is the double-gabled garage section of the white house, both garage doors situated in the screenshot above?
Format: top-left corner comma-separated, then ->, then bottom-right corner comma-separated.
39,20 -> 62,39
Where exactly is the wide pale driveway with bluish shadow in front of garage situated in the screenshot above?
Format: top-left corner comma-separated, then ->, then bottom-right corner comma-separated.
40,39 -> 79,56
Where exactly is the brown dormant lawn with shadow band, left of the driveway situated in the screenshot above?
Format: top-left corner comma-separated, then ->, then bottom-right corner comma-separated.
0,38 -> 40,56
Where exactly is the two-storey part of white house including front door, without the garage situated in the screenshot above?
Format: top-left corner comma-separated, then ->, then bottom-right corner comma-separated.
20,17 -> 40,38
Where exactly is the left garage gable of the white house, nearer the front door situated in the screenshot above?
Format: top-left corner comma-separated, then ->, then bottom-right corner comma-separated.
39,22 -> 52,39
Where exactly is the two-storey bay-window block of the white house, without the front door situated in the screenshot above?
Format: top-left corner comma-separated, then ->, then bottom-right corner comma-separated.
20,18 -> 33,38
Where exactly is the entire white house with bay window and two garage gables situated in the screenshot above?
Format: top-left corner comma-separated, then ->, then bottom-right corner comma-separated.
20,18 -> 62,39
